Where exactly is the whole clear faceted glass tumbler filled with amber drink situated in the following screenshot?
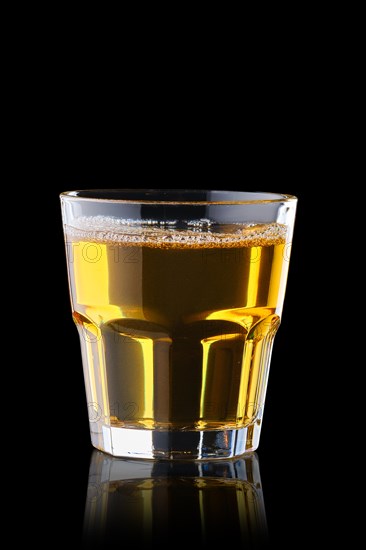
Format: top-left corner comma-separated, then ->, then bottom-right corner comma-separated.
61,189 -> 297,459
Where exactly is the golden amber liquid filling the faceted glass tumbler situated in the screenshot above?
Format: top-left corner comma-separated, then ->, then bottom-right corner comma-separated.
68,224 -> 287,430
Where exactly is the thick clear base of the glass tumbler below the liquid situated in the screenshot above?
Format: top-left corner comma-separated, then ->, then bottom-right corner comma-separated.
91,421 -> 262,460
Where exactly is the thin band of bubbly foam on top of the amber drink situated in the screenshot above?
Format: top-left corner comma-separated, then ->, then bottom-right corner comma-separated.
66,216 -> 287,248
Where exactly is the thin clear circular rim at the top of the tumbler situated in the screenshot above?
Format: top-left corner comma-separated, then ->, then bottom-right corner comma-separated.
60,189 -> 298,206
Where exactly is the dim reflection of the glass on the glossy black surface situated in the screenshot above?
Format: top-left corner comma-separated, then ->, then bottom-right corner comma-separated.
84,451 -> 267,547
